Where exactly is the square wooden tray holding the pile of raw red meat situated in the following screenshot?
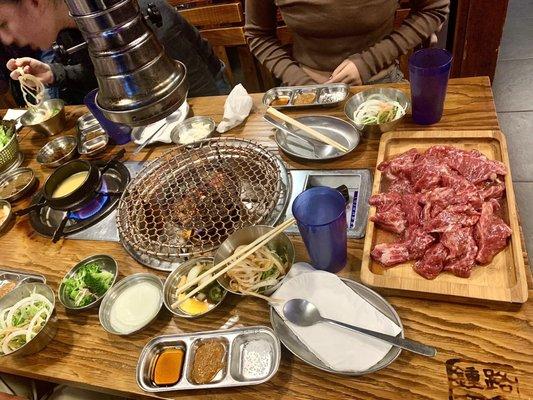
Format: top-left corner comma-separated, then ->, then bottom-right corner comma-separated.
361,131 -> 528,303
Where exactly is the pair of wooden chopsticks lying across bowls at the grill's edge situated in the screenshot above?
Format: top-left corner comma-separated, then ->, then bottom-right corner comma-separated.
172,218 -> 295,308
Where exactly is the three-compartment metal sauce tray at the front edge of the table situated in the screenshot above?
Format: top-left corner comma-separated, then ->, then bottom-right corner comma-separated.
136,326 -> 281,393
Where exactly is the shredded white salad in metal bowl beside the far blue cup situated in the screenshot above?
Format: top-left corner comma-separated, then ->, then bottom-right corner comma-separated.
353,94 -> 406,125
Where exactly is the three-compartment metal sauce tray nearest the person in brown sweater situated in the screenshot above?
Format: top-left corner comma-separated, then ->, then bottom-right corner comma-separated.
263,83 -> 350,108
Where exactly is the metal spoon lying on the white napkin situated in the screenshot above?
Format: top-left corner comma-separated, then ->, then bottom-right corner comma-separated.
283,299 -> 437,357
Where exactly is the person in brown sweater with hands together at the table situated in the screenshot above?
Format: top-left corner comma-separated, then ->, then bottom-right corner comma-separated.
245,0 -> 450,85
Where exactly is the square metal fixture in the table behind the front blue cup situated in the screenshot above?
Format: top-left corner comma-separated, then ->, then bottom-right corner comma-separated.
285,169 -> 372,239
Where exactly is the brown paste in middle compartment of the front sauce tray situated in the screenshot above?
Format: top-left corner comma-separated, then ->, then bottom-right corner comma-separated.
191,340 -> 226,384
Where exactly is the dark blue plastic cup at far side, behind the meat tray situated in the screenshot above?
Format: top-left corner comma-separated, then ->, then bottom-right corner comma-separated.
409,48 -> 452,125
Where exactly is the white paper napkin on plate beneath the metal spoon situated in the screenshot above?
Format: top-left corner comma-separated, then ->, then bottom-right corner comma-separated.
272,264 -> 401,372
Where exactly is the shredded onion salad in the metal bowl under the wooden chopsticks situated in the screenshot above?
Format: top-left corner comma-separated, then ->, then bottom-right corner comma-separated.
227,246 -> 286,295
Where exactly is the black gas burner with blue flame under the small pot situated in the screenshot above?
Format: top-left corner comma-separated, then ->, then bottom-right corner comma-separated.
30,161 -> 130,241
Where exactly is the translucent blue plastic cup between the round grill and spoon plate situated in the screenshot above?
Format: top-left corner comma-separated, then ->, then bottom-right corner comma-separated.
292,186 -> 347,273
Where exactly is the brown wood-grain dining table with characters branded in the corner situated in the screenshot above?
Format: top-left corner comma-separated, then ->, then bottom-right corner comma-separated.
0,78 -> 533,399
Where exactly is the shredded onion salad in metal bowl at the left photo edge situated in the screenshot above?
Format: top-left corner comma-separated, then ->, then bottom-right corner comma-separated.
0,292 -> 54,355
